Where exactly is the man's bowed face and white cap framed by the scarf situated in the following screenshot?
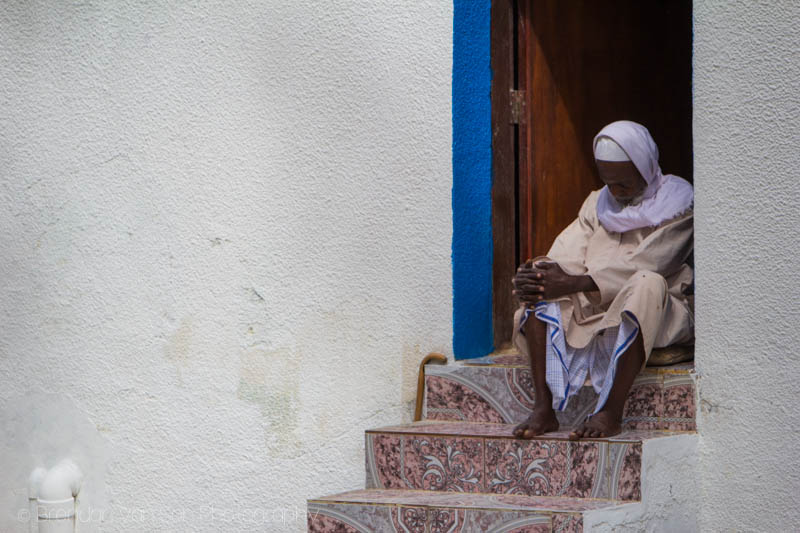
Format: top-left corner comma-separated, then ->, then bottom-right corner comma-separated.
594,136 -> 647,205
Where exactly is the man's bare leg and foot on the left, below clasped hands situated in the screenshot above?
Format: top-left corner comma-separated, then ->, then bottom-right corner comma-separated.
513,314 -> 558,439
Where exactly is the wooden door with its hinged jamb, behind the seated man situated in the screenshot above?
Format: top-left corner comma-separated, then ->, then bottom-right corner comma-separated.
492,0 -> 692,347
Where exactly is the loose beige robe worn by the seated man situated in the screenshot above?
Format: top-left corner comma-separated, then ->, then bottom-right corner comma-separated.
512,187 -> 694,359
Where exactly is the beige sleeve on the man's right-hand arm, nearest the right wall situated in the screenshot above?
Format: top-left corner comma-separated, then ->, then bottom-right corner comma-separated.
588,211 -> 694,305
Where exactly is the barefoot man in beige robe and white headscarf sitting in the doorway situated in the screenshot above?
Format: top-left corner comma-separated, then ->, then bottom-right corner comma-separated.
513,121 -> 694,440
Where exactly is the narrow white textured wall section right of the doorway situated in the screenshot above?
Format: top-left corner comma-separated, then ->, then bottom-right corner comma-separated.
694,0 -> 800,531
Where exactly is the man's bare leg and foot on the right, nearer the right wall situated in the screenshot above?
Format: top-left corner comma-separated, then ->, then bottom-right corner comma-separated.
569,330 -> 644,440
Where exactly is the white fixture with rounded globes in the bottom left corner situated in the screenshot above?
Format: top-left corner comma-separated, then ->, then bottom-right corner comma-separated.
29,459 -> 83,533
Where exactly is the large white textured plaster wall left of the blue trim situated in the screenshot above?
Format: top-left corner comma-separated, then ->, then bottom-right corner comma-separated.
0,0 -> 452,531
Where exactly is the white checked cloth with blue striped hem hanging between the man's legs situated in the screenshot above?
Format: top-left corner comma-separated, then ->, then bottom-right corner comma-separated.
519,302 -> 639,413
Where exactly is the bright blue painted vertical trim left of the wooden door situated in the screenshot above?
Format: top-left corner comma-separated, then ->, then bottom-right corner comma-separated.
452,0 -> 494,359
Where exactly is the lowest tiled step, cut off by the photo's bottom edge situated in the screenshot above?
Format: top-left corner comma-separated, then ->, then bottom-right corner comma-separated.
308,489 -> 637,533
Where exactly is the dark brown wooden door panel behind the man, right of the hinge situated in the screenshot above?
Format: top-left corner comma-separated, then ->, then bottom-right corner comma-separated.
519,0 -> 692,259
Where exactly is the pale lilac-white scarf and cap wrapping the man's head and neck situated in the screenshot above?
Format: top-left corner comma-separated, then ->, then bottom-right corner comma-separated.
593,120 -> 694,233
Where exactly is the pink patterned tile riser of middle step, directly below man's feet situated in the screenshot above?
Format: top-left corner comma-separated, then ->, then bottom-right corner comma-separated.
366,433 -> 642,501
